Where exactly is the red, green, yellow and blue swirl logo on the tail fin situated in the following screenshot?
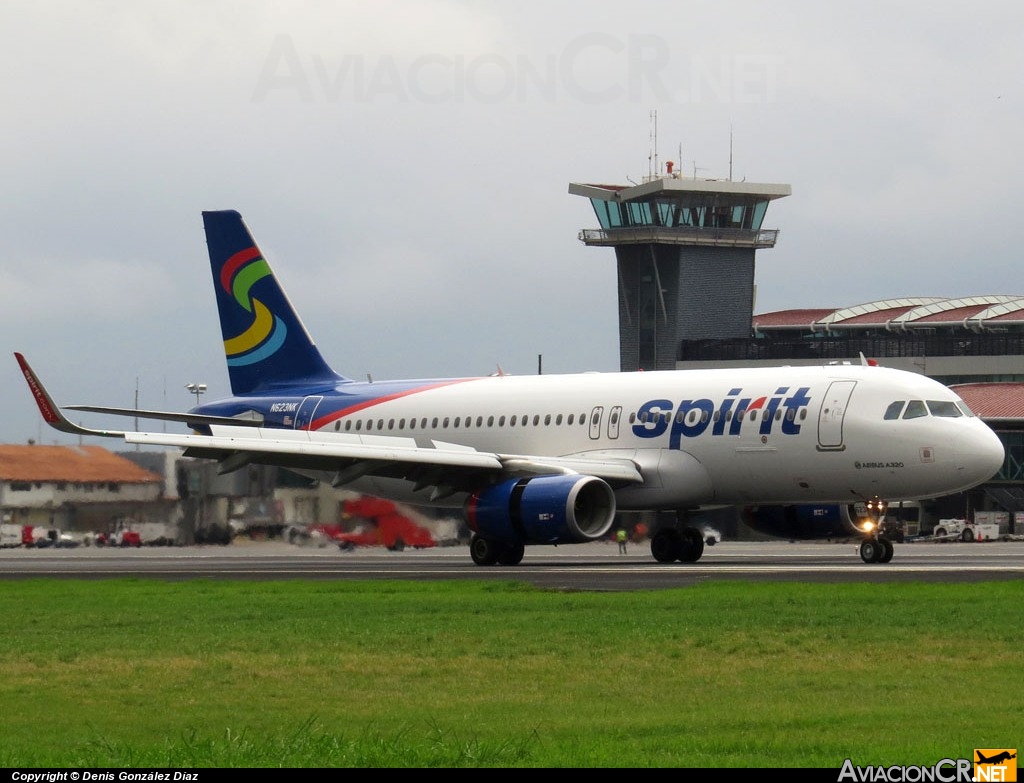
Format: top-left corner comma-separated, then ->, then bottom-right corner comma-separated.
220,247 -> 288,367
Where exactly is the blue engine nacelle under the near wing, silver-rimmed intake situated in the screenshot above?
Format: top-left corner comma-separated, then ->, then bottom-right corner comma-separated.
465,474 -> 615,545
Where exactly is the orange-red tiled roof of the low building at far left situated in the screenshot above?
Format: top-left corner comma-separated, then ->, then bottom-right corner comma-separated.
0,445 -> 163,484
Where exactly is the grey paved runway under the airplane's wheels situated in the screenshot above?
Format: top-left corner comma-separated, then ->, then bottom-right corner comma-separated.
0,540 -> 1024,591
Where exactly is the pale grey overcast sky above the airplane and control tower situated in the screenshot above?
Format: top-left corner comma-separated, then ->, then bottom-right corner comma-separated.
0,0 -> 1024,445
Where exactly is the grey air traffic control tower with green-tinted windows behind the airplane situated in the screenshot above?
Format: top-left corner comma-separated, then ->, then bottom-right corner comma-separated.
569,163 -> 792,372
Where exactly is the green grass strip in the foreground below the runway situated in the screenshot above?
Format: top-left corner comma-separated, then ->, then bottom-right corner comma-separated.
0,579 -> 1024,770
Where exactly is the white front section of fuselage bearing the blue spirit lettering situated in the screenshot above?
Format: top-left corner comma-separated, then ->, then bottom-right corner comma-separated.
292,364 -> 1002,510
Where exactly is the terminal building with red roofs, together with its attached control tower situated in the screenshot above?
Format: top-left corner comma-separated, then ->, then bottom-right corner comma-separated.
568,169 -> 1024,533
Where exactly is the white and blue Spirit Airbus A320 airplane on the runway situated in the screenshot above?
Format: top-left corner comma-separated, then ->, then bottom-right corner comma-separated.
15,205 -> 1004,566
